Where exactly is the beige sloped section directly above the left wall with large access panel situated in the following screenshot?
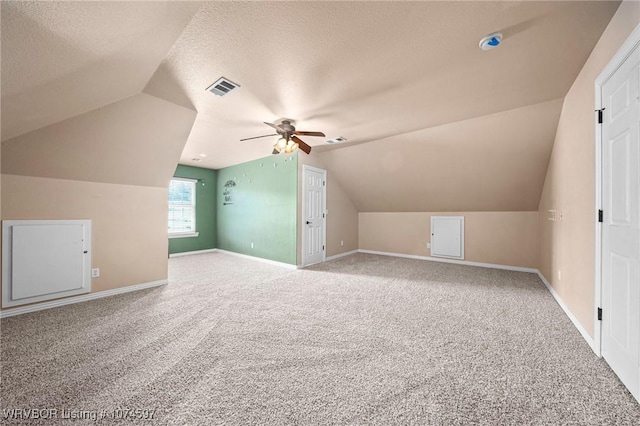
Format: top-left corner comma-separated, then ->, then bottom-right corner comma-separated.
2,93 -> 196,188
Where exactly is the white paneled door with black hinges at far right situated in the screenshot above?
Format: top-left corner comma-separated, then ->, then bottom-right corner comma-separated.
601,41 -> 640,400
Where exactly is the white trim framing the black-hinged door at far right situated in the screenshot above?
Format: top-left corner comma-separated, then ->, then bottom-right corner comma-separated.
593,25 -> 640,357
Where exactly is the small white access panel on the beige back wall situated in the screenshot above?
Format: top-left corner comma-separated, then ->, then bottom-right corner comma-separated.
431,216 -> 464,259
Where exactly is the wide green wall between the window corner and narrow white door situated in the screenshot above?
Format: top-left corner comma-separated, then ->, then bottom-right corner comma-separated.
217,153 -> 298,265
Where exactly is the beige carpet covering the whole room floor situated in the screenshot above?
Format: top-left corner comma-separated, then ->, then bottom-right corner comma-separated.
0,253 -> 640,425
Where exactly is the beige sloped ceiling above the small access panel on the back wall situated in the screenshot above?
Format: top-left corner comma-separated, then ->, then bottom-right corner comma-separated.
320,99 -> 562,212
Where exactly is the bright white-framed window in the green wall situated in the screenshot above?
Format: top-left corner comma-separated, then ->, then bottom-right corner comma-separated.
169,178 -> 198,238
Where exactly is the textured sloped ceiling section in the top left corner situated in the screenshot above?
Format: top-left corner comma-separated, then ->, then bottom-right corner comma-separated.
0,1 -> 200,140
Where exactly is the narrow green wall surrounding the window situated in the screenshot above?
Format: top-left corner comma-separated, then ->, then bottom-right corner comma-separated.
169,164 -> 218,253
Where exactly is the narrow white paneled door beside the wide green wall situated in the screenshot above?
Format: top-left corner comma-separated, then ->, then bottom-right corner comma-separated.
302,165 -> 327,266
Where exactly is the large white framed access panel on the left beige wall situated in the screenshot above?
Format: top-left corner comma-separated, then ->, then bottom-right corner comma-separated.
2,220 -> 91,308
